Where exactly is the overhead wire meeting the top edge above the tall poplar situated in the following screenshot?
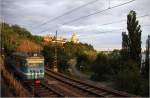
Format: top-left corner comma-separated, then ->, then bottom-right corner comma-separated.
41,0 -> 136,32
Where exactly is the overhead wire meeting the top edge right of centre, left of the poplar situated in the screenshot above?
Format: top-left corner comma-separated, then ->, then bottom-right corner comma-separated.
33,0 -> 98,29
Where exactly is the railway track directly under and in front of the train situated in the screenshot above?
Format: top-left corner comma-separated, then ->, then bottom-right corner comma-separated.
11,66 -> 64,97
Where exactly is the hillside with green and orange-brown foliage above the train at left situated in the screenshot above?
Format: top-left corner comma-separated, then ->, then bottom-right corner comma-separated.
1,23 -> 43,55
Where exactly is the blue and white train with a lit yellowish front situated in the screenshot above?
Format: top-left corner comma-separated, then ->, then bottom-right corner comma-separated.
12,52 -> 44,80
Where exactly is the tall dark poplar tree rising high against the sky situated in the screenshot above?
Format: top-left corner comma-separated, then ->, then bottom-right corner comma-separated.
127,11 -> 142,68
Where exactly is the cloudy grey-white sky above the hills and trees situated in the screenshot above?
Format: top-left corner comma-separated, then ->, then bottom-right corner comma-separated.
0,0 -> 150,50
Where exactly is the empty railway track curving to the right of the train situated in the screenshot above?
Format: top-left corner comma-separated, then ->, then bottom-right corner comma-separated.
45,68 -> 131,97
